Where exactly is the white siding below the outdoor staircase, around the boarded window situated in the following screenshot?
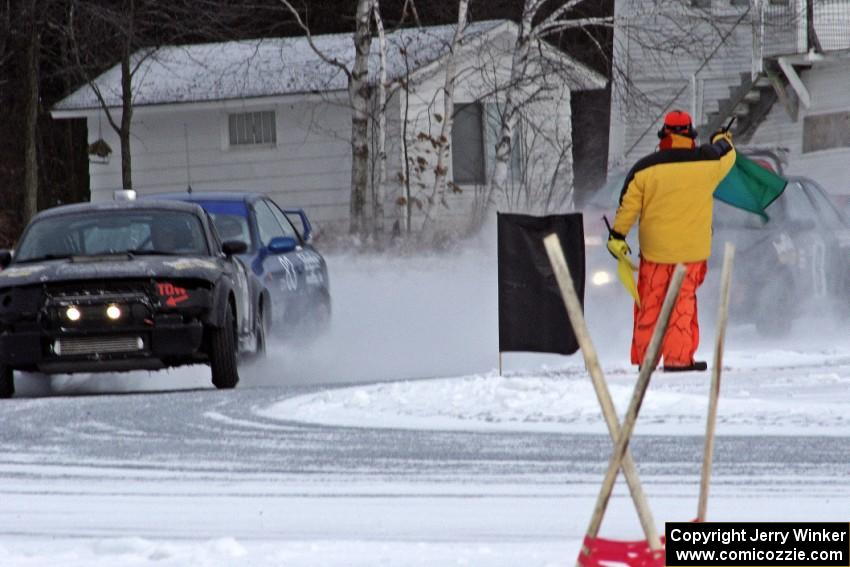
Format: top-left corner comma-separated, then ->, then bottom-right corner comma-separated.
750,59 -> 850,197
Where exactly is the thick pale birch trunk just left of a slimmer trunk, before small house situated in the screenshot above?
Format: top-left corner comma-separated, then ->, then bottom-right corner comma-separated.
348,0 -> 372,236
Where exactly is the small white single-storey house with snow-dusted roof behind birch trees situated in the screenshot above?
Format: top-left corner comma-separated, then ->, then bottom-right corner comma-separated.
52,21 -> 605,235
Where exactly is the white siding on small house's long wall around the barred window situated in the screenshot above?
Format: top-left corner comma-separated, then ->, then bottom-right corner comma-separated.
88,100 -> 351,233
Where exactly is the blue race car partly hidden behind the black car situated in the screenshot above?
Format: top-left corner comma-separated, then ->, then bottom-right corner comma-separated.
150,192 -> 331,336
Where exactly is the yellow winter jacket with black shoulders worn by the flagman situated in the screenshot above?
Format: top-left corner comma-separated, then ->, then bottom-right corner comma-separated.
613,134 -> 735,264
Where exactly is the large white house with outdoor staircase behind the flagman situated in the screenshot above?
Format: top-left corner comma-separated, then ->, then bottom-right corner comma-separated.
609,0 -> 850,206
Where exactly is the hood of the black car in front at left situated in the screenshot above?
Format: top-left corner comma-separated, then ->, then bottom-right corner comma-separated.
0,256 -> 221,287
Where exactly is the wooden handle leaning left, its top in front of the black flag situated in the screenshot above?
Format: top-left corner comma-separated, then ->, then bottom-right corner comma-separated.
543,234 -> 661,551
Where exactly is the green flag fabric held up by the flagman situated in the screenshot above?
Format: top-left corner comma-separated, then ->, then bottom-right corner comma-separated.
714,152 -> 788,221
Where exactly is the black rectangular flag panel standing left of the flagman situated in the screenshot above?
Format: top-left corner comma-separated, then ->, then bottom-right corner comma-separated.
498,213 -> 584,354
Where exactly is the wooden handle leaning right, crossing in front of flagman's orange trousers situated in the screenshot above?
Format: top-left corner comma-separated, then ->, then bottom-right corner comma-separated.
587,264 -> 685,552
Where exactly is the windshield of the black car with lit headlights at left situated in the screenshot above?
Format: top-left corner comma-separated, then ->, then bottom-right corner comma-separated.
15,209 -> 209,262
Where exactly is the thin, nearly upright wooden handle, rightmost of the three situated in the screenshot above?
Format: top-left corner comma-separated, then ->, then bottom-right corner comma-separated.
697,242 -> 735,522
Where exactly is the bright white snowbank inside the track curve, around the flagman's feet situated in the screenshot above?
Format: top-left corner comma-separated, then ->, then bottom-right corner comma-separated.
261,345 -> 850,436
